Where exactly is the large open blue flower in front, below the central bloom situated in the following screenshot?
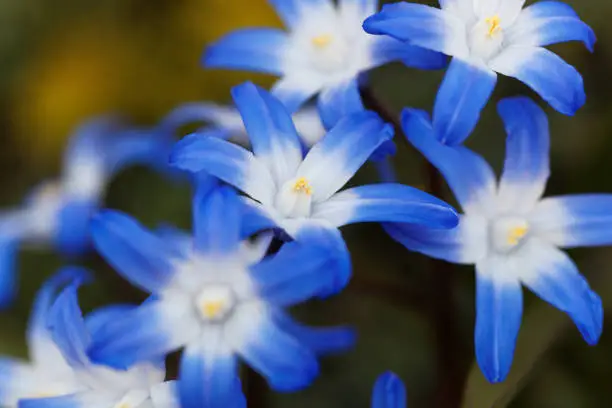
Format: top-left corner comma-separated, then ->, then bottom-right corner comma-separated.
90,185 -> 353,408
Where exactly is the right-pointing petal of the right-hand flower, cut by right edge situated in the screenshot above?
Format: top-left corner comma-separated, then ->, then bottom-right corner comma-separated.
530,194 -> 612,248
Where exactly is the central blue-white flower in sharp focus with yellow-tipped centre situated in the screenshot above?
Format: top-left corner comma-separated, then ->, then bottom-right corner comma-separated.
171,83 -> 457,242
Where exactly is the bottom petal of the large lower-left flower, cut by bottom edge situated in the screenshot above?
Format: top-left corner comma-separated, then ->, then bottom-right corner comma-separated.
178,327 -> 241,408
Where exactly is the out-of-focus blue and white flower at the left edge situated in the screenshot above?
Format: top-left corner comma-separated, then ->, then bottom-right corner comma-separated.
0,117 -> 171,305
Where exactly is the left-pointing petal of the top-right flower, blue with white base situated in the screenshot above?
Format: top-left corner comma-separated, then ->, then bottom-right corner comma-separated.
363,2 -> 469,57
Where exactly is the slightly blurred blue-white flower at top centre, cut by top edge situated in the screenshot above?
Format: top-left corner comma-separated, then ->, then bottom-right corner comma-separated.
203,0 -> 446,129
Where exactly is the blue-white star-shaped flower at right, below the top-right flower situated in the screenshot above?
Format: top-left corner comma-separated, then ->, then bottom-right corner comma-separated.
386,98 -> 612,382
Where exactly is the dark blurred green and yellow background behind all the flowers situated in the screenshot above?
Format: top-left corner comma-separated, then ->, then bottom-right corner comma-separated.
0,0 -> 612,408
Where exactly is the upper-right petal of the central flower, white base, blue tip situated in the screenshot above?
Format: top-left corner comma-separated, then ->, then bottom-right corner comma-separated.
297,111 -> 393,202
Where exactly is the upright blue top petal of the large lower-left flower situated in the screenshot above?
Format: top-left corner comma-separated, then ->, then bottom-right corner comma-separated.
193,186 -> 243,257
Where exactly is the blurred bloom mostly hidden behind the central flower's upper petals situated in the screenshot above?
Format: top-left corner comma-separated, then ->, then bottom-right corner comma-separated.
160,102 -> 325,147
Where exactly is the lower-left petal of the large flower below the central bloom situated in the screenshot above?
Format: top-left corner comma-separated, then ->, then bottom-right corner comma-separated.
88,296 -> 200,370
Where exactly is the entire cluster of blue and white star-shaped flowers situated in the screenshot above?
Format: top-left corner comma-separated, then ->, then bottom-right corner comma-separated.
0,0 -> 612,408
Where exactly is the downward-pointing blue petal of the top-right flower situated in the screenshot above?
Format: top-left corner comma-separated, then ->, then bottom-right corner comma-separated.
433,58 -> 497,146
